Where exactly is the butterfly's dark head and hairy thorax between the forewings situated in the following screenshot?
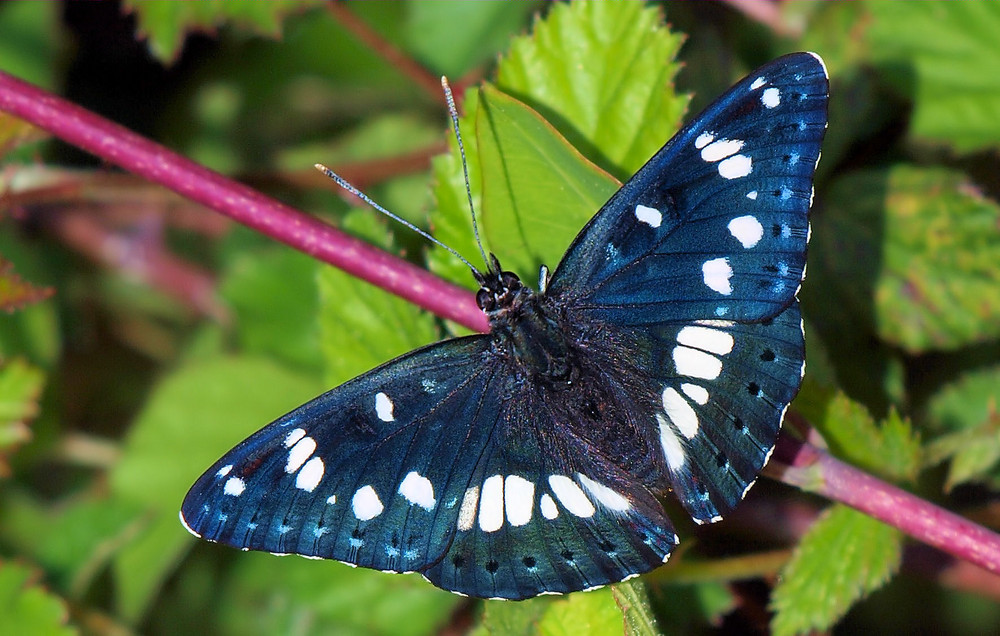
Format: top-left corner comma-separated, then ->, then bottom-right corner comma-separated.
476,257 -> 579,384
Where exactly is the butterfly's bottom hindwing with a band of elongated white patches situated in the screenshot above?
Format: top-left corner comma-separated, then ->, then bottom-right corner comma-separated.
426,373 -> 677,598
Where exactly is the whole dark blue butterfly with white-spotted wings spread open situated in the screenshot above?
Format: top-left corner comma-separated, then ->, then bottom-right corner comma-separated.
181,53 -> 828,599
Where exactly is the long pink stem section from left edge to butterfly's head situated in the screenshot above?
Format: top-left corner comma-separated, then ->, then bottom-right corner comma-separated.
0,73 -> 489,332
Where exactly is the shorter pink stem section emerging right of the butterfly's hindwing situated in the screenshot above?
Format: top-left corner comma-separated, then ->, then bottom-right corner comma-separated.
769,435 -> 1000,574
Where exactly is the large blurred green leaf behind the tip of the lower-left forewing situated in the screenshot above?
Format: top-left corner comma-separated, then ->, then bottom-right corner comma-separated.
109,356 -> 321,621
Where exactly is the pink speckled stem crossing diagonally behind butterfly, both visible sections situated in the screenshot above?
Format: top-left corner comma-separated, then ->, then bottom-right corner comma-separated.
0,73 -> 1000,588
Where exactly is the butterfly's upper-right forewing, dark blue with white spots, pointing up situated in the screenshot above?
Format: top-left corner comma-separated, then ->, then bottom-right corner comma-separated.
549,53 -> 827,324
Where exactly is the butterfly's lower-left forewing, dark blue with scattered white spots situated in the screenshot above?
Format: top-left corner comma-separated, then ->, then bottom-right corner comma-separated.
181,336 -> 496,572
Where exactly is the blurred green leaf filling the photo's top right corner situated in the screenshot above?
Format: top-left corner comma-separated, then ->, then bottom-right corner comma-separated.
867,2 -> 1000,152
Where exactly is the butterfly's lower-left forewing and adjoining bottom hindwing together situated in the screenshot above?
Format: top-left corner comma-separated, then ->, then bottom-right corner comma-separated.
181,336 -> 677,599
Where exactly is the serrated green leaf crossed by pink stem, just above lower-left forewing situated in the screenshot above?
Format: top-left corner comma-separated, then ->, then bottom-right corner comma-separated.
319,210 -> 439,384
